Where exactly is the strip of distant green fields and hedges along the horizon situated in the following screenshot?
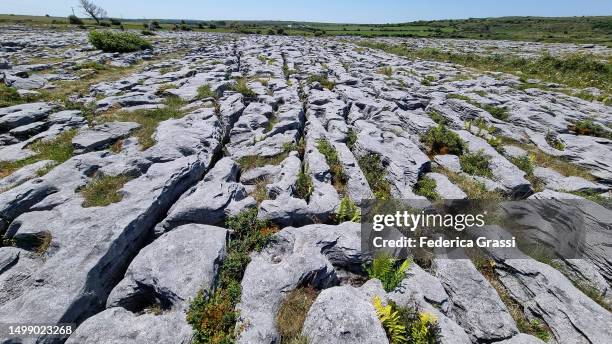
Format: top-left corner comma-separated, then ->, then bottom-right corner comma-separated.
0,14 -> 612,47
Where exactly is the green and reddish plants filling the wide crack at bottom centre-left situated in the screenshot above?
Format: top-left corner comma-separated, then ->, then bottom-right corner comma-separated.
187,208 -> 278,344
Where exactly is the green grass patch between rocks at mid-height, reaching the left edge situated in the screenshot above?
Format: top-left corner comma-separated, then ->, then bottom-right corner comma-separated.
0,130 -> 76,178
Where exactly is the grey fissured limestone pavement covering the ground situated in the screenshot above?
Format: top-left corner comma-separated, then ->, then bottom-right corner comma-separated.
0,27 -> 612,344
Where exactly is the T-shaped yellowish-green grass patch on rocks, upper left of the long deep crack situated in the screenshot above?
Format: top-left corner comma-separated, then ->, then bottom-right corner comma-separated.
97,97 -> 185,149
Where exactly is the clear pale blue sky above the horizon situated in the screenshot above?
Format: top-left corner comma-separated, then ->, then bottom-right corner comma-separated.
0,0 -> 612,23
